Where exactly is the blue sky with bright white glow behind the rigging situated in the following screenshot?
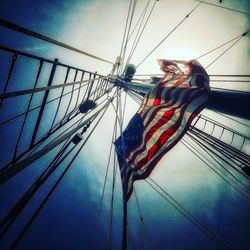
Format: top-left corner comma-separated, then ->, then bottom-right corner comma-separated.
0,0 -> 250,249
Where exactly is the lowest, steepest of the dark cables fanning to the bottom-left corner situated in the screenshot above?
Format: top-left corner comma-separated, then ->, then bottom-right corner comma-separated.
10,94 -> 110,250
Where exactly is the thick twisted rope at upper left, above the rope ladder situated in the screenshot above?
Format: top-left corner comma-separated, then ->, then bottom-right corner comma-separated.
0,18 -> 114,65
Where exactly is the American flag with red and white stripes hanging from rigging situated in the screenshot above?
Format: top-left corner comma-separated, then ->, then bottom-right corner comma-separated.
115,59 -> 209,200
